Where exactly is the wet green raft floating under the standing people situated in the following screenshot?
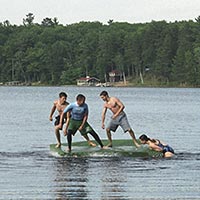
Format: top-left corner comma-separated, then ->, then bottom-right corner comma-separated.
50,139 -> 163,158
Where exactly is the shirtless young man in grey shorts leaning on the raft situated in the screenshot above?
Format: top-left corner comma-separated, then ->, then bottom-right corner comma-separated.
100,91 -> 139,147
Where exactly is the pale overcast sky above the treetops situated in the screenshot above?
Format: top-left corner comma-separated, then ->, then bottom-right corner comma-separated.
0,0 -> 200,25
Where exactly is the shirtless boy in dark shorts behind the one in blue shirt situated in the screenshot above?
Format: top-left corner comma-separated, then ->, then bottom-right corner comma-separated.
49,92 -> 69,148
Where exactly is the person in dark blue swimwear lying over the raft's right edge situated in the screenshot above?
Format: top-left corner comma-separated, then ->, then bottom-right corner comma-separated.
139,134 -> 174,158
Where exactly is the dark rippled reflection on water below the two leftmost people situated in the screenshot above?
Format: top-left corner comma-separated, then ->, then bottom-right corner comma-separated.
53,158 -> 88,199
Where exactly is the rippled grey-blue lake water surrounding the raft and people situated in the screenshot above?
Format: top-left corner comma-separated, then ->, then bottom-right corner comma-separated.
0,87 -> 200,200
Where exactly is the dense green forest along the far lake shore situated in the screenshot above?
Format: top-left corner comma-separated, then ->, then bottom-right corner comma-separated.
0,13 -> 200,87
